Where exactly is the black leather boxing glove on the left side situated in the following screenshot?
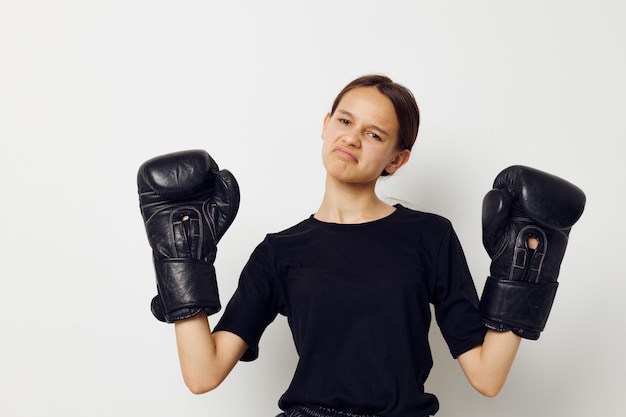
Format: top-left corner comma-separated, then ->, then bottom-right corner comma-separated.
137,150 -> 239,323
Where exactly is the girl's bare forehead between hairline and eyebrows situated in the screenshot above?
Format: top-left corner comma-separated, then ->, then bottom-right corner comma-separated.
336,87 -> 398,131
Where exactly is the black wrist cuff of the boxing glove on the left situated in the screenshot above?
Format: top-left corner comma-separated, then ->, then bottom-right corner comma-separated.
152,258 -> 221,323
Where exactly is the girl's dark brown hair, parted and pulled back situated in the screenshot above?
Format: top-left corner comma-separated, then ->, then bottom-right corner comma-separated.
331,75 -> 420,150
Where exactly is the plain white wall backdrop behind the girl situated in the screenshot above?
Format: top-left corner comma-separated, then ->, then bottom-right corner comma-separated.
0,0 -> 626,417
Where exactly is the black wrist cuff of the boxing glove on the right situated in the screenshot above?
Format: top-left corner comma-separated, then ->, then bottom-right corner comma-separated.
479,277 -> 559,340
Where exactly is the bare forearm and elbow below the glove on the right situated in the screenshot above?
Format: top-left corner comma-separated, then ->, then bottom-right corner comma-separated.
458,330 -> 521,397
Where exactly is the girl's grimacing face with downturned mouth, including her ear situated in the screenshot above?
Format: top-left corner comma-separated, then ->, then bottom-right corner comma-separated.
322,87 -> 410,184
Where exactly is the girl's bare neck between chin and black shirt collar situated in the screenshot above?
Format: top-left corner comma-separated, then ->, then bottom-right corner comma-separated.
314,176 -> 395,224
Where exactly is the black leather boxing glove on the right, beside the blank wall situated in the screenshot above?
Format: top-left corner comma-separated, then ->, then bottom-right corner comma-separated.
479,165 -> 586,340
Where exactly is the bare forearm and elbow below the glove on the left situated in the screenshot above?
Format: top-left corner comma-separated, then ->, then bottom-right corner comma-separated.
175,313 -> 248,394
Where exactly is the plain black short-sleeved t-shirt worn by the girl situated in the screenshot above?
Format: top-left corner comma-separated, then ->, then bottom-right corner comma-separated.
215,205 -> 485,417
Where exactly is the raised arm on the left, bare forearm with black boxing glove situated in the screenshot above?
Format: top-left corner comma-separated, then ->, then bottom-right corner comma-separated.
137,150 -> 247,393
